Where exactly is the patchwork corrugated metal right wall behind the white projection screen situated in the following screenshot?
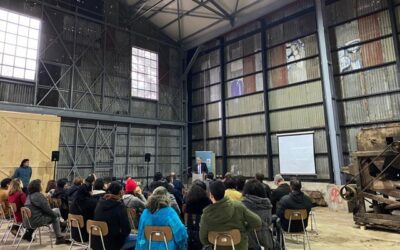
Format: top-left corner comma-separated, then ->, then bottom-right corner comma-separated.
192,0 -> 400,180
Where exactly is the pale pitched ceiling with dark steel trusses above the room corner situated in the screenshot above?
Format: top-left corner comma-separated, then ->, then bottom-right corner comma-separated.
124,0 -> 293,49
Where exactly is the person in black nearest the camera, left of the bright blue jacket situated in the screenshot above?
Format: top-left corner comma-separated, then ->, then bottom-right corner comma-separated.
92,181 -> 136,250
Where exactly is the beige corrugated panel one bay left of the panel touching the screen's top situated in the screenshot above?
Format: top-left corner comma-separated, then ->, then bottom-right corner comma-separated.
226,114 -> 265,135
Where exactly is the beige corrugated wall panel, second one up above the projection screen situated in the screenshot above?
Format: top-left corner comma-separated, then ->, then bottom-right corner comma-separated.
268,81 -> 323,110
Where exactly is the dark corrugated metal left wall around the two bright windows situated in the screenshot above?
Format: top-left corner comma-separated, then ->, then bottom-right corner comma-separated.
0,0 -> 184,179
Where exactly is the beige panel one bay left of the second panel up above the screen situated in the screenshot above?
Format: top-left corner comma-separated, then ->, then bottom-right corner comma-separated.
225,93 -> 264,117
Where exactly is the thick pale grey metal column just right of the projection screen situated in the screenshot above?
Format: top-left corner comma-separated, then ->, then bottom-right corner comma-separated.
315,0 -> 344,184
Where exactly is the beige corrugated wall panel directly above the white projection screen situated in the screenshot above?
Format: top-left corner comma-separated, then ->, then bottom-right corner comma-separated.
270,105 -> 325,132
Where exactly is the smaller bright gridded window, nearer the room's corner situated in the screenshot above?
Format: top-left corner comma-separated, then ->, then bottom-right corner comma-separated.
132,47 -> 158,100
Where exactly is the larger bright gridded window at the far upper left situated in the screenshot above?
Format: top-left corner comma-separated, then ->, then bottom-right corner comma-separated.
0,9 -> 40,81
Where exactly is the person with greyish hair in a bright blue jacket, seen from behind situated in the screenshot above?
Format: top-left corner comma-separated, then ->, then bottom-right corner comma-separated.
135,186 -> 188,250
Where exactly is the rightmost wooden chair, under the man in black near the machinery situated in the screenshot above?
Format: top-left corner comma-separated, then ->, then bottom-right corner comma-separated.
284,209 -> 311,249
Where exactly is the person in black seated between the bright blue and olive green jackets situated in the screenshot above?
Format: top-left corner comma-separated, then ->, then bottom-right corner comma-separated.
185,180 -> 211,250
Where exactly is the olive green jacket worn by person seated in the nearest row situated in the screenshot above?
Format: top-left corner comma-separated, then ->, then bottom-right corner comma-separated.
200,197 -> 261,250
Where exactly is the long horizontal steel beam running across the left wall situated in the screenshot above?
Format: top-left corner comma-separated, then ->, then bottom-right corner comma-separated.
0,102 -> 186,126
